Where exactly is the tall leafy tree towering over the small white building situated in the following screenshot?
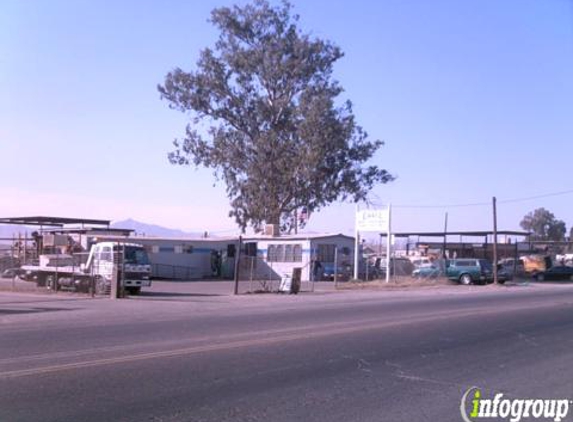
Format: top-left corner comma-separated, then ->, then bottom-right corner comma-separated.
158,0 -> 392,230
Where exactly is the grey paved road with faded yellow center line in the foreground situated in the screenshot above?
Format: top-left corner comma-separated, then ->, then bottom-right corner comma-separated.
0,285 -> 573,422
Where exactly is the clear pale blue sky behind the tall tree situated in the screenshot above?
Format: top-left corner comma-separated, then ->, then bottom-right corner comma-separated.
0,0 -> 573,234
